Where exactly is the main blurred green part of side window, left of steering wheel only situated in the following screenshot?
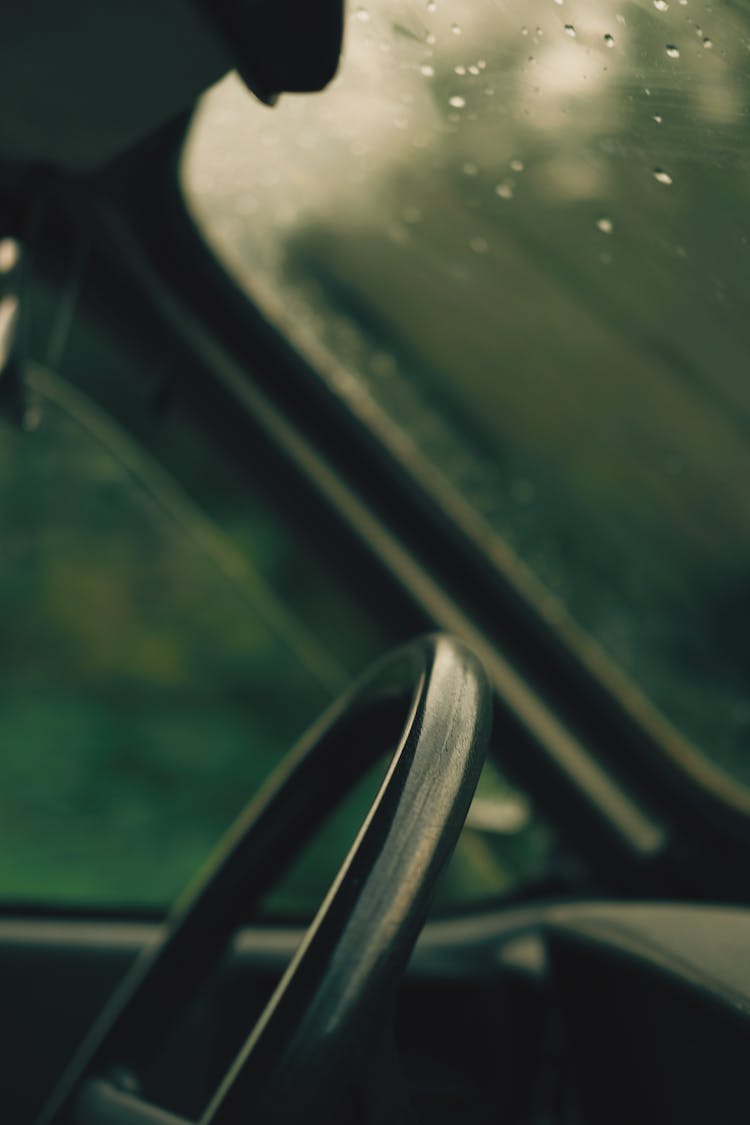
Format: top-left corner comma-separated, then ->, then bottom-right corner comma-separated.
0,369 -> 386,906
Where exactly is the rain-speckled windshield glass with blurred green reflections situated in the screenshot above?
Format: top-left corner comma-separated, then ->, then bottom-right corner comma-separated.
183,0 -> 750,781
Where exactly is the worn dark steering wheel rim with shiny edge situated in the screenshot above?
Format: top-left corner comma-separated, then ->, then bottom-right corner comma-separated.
37,636 -> 490,1125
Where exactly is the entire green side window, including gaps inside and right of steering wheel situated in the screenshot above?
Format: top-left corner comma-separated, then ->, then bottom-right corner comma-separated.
0,276 -> 551,917
